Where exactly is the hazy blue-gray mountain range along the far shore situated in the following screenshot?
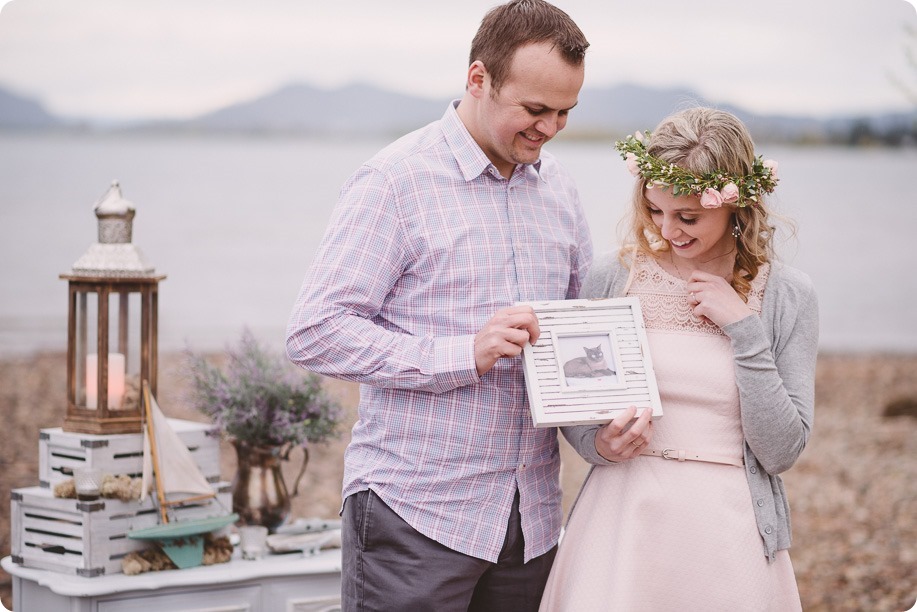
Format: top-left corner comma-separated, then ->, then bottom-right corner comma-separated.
0,84 -> 917,144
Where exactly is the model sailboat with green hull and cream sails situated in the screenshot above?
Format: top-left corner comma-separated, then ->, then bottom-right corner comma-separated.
128,381 -> 239,569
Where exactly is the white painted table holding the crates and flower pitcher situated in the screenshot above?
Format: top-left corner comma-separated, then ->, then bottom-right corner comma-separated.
0,549 -> 341,612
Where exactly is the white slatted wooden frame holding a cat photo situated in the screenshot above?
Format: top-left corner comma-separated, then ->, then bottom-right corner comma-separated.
520,297 -> 662,427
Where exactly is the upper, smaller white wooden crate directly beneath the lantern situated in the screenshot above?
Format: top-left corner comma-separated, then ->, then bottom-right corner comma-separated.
38,419 -> 220,488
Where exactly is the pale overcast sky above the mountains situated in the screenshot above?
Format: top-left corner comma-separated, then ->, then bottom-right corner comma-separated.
0,0 -> 917,119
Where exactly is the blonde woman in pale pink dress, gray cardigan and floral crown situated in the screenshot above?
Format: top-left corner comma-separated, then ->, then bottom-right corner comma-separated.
542,108 -> 818,612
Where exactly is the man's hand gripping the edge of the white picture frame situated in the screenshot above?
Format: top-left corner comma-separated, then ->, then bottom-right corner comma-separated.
474,306 -> 541,376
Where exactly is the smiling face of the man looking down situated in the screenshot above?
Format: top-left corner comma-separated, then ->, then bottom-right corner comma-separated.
472,43 -> 584,177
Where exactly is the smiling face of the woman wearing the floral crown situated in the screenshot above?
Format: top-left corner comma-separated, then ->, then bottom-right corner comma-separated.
644,188 -> 735,263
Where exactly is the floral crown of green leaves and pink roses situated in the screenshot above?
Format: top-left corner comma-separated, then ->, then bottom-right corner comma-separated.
615,132 -> 777,208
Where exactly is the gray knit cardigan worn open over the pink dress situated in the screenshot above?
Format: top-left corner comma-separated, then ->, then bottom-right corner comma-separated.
562,254 -> 818,561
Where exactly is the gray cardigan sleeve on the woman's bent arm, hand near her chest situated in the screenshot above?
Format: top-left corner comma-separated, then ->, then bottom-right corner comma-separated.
723,268 -> 818,474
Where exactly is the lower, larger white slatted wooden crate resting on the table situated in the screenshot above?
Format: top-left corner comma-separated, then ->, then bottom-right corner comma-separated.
10,482 -> 232,577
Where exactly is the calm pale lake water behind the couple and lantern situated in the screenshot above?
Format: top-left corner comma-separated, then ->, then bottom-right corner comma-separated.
0,134 -> 917,355
